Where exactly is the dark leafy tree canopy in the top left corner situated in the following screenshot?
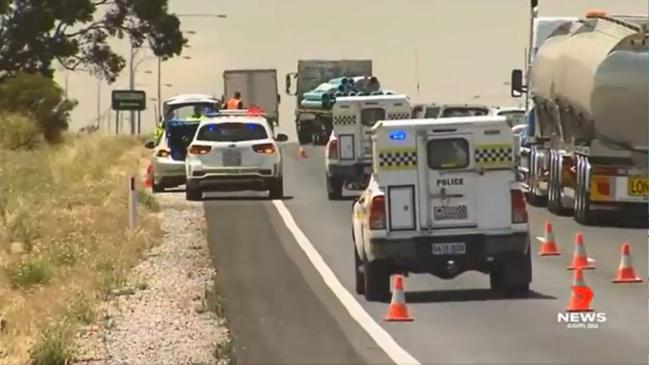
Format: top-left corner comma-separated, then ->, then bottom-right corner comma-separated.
0,0 -> 187,82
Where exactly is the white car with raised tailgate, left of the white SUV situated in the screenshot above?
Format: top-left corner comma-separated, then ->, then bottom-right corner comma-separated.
145,94 -> 220,193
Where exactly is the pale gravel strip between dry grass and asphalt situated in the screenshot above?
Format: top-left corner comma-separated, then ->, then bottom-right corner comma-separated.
73,193 -> 231,365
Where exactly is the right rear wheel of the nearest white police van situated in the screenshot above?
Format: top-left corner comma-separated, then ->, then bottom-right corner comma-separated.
489,249 -> 532,297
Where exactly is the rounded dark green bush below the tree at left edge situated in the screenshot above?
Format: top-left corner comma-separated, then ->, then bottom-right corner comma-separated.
0,73 -> 77,143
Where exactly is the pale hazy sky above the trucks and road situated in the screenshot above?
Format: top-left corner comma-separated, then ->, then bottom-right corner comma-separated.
55,0 -> 648,137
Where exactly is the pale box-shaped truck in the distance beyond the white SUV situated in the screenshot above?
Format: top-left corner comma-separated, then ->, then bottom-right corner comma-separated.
223,69 -> 280,128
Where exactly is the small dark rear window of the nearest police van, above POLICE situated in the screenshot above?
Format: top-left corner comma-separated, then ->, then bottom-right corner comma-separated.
427,138 -> 469,170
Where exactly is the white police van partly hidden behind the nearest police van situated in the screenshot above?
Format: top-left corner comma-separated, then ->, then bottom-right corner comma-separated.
325,94 -> 410,199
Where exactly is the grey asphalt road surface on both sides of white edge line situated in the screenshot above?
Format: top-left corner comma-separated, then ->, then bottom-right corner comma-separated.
205,145 -> 647,364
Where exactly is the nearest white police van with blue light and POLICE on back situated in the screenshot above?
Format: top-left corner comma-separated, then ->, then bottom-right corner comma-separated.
352,116 -> 532,300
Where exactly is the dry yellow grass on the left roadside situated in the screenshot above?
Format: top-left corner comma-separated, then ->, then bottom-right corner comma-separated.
0,135 -> 160,364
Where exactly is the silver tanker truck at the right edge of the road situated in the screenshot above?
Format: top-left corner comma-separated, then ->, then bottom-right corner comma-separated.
511,11 -> 649,225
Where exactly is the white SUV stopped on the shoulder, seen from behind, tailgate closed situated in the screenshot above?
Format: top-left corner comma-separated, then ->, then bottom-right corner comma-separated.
185,115 -> 288,200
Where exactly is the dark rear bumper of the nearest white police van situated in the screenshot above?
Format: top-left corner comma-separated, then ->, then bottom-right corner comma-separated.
366,232 -> 530,277
